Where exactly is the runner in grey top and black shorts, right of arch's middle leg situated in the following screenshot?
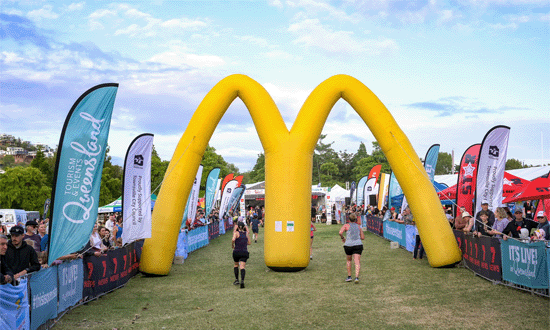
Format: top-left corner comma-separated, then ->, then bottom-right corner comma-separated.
340,213 -> 365,283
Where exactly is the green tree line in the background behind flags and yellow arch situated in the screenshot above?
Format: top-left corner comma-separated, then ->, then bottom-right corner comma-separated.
0,135 -> 544,211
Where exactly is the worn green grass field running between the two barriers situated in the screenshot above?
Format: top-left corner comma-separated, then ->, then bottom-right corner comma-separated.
55,224 -> 550,329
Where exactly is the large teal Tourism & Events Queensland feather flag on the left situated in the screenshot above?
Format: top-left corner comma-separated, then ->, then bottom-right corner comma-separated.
48,83 -> 118,264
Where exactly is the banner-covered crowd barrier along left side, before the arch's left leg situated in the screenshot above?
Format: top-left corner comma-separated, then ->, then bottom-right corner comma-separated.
0,241 -> 143,330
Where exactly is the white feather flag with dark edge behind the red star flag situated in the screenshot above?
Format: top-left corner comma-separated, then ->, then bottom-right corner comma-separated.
475,126 -> 510,217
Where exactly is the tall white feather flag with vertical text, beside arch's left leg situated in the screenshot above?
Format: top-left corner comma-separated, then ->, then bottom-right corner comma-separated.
122,133 -> 153,244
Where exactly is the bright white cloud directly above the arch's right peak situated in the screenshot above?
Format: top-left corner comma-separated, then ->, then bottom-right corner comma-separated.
288,19 -> 399,55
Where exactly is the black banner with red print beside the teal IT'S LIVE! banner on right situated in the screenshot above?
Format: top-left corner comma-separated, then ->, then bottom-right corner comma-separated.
454,230 -> 502,281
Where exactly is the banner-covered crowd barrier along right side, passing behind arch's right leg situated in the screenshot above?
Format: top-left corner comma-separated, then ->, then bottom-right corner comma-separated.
366,216 -> 550,297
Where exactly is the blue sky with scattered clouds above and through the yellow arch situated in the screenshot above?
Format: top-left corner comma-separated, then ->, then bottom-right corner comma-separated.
0,0 -> 550,171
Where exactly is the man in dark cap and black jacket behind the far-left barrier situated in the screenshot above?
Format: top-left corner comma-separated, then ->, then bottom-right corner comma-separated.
6,226 -> 40,279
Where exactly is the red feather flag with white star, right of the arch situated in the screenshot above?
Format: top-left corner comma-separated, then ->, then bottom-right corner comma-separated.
455,143 -> 481,216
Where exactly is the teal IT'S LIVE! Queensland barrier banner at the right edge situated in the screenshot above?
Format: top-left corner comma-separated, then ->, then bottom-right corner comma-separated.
500,239 -> 548,289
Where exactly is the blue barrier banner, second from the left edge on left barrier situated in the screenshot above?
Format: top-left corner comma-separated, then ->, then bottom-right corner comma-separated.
29,266 -> 57,330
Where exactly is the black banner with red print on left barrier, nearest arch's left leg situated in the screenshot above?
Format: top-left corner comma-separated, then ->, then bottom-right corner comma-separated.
82,240 -> 143,298
